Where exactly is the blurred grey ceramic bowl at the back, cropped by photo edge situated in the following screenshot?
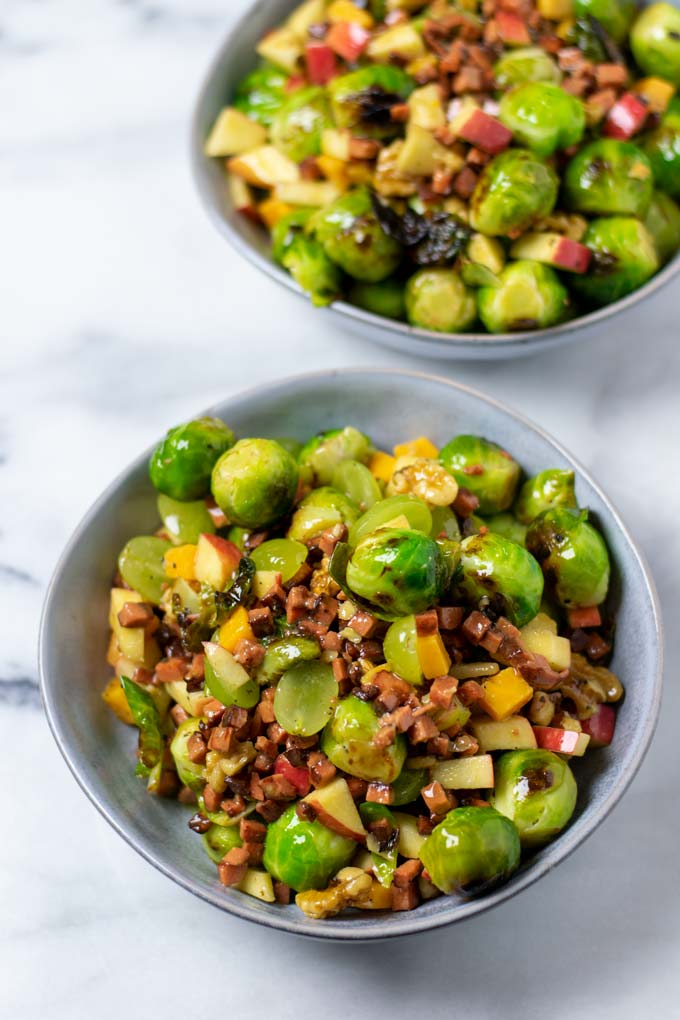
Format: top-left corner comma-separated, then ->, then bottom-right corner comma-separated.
192,0 -> 680,359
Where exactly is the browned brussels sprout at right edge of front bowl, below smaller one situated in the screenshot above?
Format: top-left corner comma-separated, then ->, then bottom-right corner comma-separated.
526,507 -> 610,608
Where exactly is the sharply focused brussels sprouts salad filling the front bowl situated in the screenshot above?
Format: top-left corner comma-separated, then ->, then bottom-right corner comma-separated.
103,418 -> 623,918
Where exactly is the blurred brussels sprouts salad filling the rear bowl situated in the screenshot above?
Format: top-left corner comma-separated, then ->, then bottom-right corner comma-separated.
205,0 -> 680,334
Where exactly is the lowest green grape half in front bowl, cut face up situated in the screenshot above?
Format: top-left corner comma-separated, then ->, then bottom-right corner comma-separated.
274,660 -> 337,736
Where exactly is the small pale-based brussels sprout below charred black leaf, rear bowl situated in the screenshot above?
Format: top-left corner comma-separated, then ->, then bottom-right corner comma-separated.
405,268 -> 477,333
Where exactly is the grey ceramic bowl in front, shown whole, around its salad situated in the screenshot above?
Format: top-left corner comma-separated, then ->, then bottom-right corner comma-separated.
40,369 -> 662,940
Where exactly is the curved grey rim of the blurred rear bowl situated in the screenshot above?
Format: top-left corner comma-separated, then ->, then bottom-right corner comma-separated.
190,0 -> 680,357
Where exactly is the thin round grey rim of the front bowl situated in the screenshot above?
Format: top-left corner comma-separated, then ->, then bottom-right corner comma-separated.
38,367 -> 664,942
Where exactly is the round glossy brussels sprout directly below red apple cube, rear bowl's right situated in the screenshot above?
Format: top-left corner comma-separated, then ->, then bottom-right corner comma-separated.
564,138 -> 653,216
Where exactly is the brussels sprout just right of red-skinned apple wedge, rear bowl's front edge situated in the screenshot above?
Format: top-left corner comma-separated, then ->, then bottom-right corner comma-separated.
573,216 -> 659,305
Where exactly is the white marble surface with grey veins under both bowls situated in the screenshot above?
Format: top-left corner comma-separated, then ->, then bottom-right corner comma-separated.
0,0 -> 680,1020
